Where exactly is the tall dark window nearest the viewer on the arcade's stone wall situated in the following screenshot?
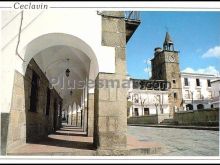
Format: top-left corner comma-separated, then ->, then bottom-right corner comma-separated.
30,71 -> 38,112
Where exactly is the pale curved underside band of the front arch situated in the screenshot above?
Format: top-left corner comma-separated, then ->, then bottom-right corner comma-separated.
21,33 -> 99,80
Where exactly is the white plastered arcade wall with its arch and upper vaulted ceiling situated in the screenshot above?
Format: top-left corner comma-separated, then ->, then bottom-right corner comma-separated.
0,8 -> 115,113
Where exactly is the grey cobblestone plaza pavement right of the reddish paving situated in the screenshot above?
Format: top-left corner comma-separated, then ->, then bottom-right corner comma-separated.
128,126 -> 219,156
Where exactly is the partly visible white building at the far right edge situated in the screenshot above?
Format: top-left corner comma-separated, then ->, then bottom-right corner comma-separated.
211,78 -> 220,108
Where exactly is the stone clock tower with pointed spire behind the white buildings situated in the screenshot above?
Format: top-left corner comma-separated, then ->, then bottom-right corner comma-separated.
151,32 -> 182,115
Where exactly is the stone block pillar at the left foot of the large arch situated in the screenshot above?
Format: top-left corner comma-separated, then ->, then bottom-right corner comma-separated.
5,71 -> 26,154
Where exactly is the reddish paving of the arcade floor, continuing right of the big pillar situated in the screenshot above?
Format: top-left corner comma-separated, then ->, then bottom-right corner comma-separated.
7,125 -> 161,156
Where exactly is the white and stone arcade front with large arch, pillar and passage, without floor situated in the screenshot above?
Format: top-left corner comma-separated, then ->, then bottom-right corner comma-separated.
5,11 -> 130,155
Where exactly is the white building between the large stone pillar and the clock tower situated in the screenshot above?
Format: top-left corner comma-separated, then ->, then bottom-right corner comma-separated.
128,79 -> 170,117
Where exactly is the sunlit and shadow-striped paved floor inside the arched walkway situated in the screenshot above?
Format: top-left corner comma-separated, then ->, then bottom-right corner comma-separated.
8,126 -> 94,155
